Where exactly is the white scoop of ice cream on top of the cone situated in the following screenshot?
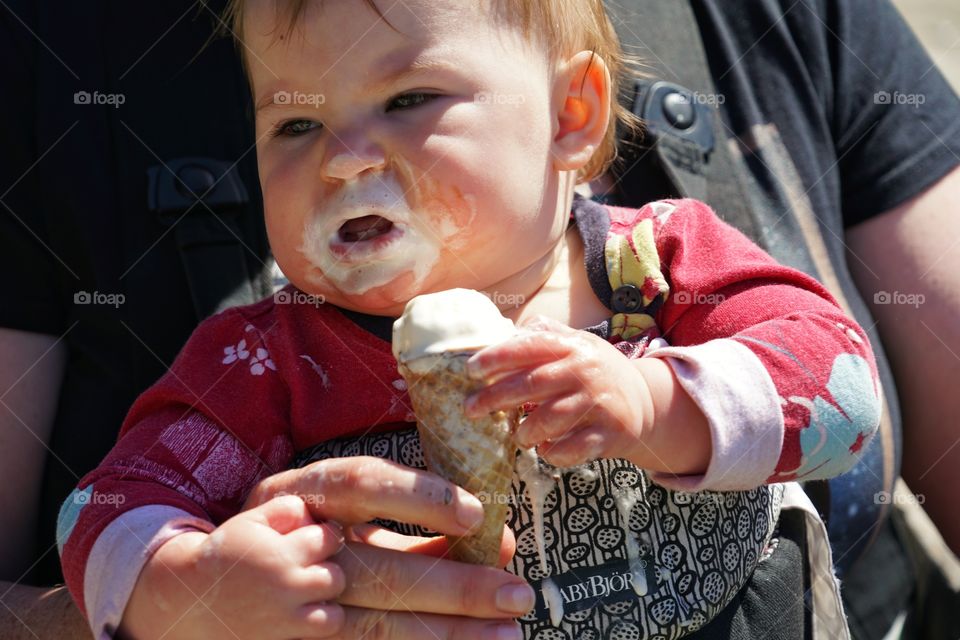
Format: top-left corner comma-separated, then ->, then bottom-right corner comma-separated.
393,289 -> 516,364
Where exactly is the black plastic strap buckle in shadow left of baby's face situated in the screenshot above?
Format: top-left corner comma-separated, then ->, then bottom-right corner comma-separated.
147,158 -> 250,224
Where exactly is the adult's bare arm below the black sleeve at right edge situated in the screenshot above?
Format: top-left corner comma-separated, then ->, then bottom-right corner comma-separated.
847,162 -> 960,554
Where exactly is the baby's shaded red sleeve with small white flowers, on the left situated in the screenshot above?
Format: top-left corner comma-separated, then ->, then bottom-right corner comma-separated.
57,309 -> 293,638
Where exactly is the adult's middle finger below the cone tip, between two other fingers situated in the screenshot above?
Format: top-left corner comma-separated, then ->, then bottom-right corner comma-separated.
336,542 -> 534,619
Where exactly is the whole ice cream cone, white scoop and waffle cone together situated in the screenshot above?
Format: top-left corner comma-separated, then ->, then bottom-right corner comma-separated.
393,289 -> 520,566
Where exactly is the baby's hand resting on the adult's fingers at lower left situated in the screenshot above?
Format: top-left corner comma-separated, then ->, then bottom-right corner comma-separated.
120,496 -> 345,640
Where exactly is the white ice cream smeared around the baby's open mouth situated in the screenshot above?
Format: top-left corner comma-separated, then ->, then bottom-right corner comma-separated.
299,163 -> 476,295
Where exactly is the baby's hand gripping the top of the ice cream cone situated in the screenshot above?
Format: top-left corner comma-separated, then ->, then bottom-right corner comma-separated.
466,316 -> 710,474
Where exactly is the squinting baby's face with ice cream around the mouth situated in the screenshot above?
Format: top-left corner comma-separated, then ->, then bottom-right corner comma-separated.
243,0 -> 568,315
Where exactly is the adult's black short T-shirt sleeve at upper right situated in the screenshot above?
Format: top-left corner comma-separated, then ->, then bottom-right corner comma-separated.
824,0 -> 960,225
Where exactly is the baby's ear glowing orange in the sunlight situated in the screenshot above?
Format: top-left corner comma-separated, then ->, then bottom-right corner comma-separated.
551,51 -> 610,171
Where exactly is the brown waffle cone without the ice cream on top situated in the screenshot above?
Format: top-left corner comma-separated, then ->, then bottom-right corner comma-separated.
400,353 -> 520,566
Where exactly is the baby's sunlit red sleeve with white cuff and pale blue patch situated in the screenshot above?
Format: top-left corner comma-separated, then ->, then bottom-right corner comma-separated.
647,200 -> 881,490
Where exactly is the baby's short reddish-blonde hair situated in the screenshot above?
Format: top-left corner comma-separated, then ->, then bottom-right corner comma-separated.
221,0 -> 641,182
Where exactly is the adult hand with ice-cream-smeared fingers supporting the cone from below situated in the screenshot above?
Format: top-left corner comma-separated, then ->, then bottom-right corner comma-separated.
245,456 -> 534,640
